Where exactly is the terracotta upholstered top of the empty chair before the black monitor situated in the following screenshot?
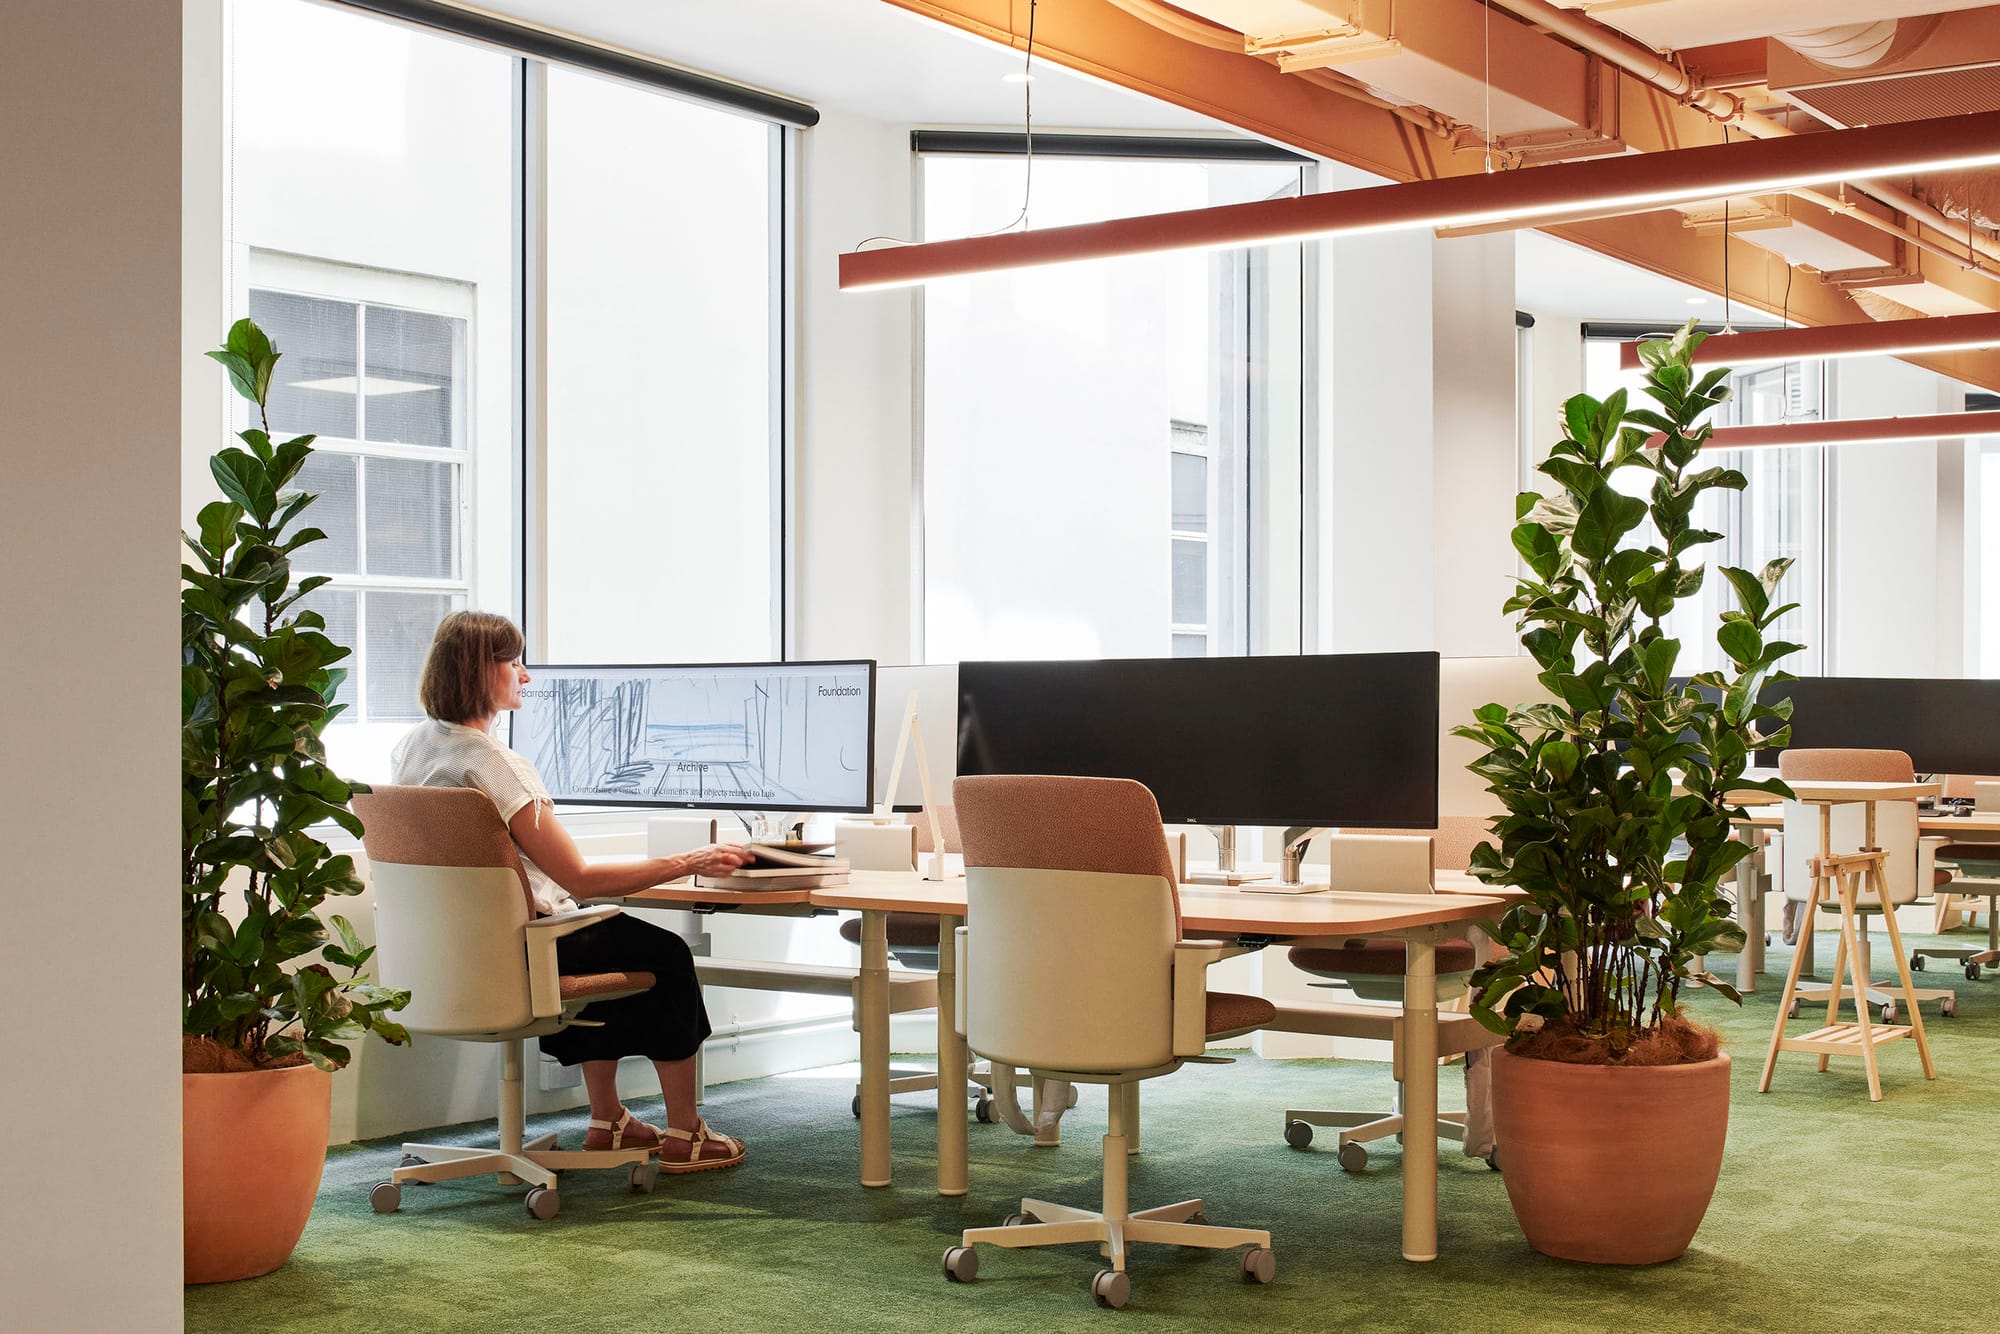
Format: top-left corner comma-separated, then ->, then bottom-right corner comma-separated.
952,774 -> 1180,932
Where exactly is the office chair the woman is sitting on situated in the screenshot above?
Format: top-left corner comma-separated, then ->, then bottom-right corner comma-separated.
354,786 -> 660,1218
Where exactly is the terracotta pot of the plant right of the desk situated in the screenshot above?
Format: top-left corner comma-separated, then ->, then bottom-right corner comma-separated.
1494,1050 -> 1730,1264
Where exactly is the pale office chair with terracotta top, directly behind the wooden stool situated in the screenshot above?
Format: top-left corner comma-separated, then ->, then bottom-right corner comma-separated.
1778,750 -> 1958,1024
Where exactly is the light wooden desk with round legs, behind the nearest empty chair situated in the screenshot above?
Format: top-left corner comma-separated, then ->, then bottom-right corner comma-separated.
810,872 -> 1506,1260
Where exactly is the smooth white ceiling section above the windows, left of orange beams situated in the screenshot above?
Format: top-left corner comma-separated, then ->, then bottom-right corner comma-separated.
480,0 -> 1230,134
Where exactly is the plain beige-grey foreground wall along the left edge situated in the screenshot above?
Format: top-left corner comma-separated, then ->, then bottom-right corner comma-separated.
0,0 -> 182,1330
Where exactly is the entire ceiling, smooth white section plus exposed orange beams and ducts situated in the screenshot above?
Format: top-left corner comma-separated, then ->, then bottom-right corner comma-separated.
464,0 -> 2000,388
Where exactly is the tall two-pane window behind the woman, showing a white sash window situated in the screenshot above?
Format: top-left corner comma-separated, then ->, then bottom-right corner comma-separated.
230,0 -> 786,780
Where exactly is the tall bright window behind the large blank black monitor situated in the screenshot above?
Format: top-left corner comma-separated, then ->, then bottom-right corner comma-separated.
920,147 -> 1302,662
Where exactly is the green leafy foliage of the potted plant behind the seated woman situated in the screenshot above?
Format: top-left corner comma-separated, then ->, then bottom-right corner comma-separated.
180,320 -> 410,1070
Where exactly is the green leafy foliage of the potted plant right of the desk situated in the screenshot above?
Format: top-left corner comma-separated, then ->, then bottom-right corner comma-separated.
1454,322 -> 1800,1062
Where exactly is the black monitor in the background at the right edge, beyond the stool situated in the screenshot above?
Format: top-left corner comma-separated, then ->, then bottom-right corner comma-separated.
1758,676 -> 2000,774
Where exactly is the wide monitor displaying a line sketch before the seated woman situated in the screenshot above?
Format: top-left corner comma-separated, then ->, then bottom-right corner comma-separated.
512,660 -> 874,812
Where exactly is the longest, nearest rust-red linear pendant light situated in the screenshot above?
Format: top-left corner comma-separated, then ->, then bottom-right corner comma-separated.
840,112 -> 2000,292
